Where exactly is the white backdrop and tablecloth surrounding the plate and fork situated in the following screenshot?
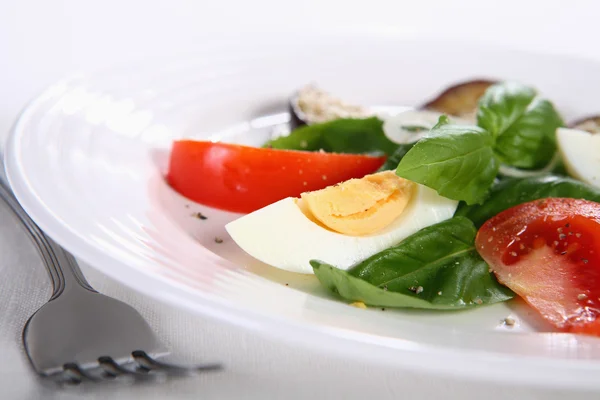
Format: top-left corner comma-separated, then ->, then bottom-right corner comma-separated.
0,0 -> 600,399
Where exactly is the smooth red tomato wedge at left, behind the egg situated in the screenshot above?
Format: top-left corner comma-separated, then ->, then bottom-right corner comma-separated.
166,140 -> 385,213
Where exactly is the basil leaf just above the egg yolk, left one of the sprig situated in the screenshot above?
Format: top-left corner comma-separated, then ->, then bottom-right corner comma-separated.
396,123 -> 499,204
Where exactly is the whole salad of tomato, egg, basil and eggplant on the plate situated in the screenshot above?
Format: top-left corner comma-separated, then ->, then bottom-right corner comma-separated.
167,80 -> 600,335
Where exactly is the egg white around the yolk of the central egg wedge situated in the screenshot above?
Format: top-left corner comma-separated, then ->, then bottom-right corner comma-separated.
225,185 -> 458,274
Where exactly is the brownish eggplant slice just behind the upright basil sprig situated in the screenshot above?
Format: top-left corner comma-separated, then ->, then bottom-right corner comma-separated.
422,79 -> 498,117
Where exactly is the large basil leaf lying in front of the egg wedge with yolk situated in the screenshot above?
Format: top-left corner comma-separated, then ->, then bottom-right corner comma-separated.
310,217 -> 513,309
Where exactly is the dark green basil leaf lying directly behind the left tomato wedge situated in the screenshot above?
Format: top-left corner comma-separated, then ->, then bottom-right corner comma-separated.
265,117 -> 398,155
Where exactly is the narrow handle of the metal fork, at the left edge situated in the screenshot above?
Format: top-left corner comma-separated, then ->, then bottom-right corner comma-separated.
0,179 -> 96,300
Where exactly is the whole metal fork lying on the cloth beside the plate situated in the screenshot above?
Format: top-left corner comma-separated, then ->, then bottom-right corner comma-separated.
0,179 -> 221,384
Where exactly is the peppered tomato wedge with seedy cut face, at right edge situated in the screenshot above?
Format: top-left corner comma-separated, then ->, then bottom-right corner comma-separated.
475,198 -> 600,336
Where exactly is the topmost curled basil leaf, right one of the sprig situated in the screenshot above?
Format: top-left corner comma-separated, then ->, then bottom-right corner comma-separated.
477,83 -> 563,169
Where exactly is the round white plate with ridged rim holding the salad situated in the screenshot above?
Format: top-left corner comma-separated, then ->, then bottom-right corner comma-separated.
6,35 -> 600,388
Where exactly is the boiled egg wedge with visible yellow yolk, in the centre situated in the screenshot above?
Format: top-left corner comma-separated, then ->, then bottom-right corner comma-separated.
225,171 -> 458,274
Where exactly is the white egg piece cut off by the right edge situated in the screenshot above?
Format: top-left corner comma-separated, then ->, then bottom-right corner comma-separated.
556,128 -> 600,188
